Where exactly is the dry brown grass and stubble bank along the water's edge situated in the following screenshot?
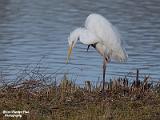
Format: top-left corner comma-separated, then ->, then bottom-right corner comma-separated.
0,68 -> 160,120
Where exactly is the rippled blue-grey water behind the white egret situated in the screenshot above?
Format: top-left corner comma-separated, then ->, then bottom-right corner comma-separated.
0,0 -> 160,81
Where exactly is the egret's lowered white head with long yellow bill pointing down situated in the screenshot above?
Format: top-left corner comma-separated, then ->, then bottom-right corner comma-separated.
66,28 -> 82,63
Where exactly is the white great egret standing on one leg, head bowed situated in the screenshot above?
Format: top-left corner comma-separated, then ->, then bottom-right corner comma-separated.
66,14 -> 128,91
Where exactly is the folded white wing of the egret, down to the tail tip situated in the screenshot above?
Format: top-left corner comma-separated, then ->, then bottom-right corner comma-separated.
85,14 -> 128,61
